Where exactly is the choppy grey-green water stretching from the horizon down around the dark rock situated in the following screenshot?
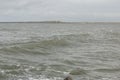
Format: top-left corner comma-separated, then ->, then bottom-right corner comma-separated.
0,23 -> 120,80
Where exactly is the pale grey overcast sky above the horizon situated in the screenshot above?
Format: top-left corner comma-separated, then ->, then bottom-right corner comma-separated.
0,0 -> 120,22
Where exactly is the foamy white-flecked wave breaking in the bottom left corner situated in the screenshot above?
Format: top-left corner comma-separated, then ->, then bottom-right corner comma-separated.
0,64 -> 63,80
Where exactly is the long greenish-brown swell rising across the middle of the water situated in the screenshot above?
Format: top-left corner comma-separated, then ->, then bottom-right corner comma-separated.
0,34 -> 90,55
